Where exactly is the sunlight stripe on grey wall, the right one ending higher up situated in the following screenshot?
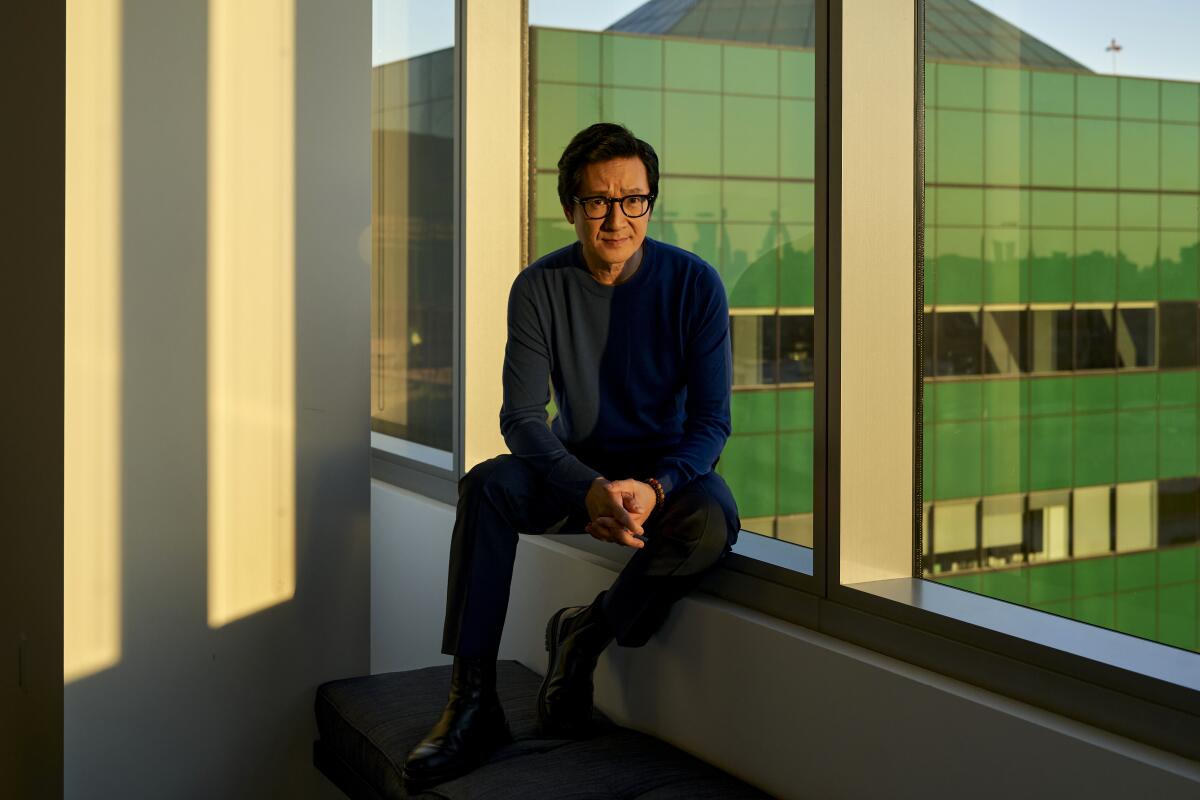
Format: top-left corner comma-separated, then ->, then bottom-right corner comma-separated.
208,0 -> 295,627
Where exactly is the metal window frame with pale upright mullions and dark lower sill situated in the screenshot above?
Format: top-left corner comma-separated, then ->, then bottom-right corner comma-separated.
372,0 -> 1200,759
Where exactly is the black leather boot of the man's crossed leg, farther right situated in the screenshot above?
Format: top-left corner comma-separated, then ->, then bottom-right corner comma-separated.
538,591 -> 613,739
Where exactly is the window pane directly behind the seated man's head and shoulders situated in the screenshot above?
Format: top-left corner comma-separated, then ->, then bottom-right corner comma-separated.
529,0 -> 820,556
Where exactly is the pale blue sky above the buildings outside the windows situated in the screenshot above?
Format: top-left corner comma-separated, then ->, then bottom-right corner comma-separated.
372,0 -> 1200,82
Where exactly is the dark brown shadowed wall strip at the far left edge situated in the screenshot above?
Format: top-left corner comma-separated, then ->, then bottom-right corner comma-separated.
0,2 -> 66,798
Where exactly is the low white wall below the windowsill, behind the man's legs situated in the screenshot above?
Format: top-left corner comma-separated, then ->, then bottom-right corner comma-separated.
371,482 -> 1200,799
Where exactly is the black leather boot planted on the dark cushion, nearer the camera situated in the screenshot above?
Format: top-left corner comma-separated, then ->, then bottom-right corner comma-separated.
404,656 -> 512,793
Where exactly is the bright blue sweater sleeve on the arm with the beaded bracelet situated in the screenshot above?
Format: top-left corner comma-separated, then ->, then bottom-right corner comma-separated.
655,267 -> 733,493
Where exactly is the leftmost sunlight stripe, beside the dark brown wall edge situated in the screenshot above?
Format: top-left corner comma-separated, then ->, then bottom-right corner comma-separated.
62,0 -> 121,682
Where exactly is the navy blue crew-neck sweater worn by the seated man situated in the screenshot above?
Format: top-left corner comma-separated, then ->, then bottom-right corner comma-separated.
500,239 -> 733,505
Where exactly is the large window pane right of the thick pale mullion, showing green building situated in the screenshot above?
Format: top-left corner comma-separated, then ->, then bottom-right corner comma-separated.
922,0 -> 1200,650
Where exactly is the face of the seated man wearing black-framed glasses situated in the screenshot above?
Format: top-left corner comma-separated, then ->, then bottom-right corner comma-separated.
563,157 -> 652,264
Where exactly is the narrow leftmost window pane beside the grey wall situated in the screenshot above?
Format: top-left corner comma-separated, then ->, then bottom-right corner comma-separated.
371,0 -> 453,460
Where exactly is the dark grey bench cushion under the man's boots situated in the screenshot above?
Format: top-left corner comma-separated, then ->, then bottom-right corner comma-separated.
316,661 -> 767,800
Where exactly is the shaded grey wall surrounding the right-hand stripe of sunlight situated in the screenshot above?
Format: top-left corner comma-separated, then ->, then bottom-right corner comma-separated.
65,0 -> 371,798
